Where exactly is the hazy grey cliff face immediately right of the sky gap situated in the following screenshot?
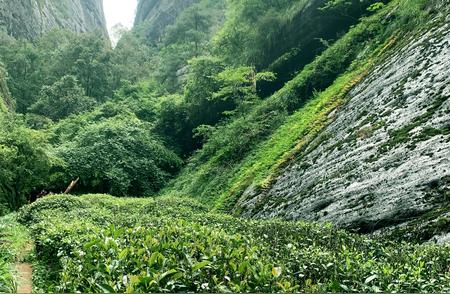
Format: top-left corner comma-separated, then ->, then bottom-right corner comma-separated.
134,0 -> 199,43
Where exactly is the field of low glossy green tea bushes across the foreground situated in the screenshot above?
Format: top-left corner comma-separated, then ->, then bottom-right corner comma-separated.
15,195 -> 450,293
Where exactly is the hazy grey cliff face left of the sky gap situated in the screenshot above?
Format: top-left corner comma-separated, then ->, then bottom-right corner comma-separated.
0,0 -> 107,40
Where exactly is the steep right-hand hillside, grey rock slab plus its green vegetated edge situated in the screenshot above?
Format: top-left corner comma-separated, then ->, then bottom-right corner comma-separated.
166,2 -> 449,238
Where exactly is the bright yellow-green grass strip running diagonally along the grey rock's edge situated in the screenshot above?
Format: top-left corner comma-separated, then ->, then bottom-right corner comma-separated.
216,63 -> 372,210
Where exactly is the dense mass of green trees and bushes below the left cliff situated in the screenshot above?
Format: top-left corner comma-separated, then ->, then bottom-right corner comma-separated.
0,26 -> 181,208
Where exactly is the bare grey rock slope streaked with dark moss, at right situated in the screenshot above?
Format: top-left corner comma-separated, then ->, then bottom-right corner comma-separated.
235,17 -> 450,232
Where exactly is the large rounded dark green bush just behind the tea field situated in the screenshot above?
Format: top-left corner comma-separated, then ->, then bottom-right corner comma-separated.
57,116 -> 181,196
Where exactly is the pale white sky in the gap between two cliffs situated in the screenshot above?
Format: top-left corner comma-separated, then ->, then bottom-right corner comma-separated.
103,0 -> 137,41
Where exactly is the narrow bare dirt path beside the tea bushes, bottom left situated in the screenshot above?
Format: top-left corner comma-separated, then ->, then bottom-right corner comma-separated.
14,244 -> 33,294
